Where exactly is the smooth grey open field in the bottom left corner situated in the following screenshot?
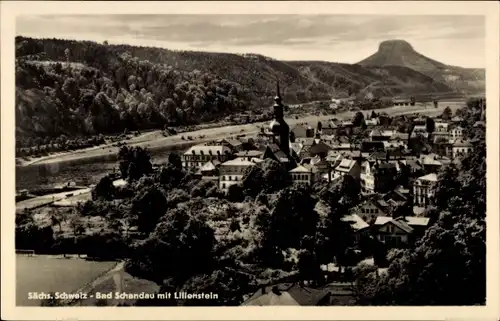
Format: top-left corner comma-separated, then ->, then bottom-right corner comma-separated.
16,255 -> 116,306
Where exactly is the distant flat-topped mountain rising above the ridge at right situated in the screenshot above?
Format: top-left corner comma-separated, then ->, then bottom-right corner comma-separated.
358,40 -> 485,93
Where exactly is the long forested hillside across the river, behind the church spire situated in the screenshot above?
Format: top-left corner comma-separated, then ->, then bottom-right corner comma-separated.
16,37 -> 458,141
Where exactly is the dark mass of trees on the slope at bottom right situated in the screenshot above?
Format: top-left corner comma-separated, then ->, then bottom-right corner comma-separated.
363,141 -> 486,305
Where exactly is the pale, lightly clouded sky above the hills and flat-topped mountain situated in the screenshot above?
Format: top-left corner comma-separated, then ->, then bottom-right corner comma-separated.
16,14 -> 486,68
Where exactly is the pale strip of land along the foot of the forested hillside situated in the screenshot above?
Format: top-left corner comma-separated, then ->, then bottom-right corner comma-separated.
16,101 -> 465,166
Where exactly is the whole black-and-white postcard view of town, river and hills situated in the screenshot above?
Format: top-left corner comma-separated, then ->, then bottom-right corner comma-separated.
2,1 -> 498,317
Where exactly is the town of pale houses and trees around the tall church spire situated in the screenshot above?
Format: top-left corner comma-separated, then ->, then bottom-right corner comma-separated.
17,83 -> 486,305
